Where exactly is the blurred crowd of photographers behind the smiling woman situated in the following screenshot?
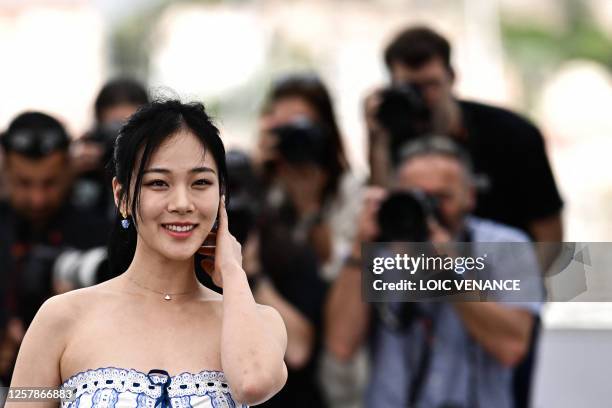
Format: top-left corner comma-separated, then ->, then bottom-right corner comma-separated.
0,26 -> 563,408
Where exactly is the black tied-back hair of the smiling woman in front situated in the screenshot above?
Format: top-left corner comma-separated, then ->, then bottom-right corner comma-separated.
109,100 -> 227,276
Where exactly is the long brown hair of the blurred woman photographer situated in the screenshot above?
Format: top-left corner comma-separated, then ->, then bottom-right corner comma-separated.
265,73 -> 349,202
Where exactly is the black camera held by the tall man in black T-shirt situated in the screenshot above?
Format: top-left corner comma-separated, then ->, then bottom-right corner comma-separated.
376,83 -> 433,166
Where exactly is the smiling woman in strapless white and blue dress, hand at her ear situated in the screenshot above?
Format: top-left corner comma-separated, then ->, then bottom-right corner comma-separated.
7,101 -> 287,408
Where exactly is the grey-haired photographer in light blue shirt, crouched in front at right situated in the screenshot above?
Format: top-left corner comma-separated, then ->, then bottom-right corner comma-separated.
326,136 -> 540,408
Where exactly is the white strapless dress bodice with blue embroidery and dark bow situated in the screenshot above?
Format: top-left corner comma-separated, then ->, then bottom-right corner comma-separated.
62,367 -> 247,408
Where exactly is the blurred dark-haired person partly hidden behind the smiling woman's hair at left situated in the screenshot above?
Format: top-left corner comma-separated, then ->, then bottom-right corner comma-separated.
71,78 -> 149,220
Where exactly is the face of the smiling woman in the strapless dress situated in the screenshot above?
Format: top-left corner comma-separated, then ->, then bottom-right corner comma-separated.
113,129 -> 225,270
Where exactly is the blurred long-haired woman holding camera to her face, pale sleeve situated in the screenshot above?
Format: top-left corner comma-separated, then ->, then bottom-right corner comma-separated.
258,74 -> 362,281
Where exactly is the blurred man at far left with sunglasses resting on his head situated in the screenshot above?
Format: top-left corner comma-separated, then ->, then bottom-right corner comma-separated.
0,112 -> 107,383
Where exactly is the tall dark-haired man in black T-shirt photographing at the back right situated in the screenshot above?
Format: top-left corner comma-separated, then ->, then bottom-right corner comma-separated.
365,27 -> 562,242
